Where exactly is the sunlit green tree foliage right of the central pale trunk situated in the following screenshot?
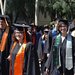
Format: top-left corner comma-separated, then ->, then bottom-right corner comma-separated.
39,0 -> 75,19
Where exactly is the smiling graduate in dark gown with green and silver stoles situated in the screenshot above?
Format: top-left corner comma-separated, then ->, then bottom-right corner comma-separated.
45,20 -> 75,75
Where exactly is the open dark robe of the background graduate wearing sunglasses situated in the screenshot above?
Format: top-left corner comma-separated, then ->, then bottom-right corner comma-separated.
37,37 -> 47,73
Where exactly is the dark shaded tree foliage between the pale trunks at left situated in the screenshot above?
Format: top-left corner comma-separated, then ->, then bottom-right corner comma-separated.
6,0 -> 35,23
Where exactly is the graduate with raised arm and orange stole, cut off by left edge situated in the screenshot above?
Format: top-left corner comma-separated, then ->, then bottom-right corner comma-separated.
0,15 -> 11,75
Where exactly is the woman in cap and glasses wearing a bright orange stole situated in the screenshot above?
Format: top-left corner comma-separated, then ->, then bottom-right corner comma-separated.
8,24 -> 39,75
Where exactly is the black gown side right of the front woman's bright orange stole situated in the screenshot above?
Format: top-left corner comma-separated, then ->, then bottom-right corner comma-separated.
23,42 -> 40,75
